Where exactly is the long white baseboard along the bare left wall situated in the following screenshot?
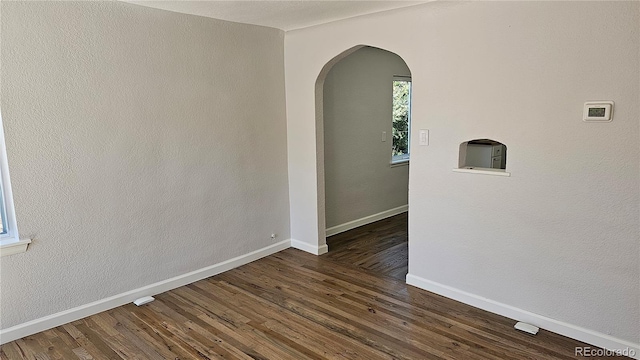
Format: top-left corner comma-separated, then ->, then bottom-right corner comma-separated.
0,240 -> 291,344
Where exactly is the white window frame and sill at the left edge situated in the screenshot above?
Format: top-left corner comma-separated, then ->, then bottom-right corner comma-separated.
0,110 -> 31,256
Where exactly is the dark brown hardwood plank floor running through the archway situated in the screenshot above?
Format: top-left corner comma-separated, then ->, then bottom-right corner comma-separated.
0,215 -> 608,359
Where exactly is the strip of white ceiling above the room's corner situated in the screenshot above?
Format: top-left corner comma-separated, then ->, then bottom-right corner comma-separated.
121,0 -> 428,31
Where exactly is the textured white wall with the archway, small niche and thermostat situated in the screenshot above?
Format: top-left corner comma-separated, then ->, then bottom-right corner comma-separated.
285,2 -> 640,343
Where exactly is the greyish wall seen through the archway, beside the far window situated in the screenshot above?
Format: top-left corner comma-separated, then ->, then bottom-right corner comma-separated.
323,47 -> 411,228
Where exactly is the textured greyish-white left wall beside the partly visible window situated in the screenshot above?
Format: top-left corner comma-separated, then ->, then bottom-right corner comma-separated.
0,1 -> 289,328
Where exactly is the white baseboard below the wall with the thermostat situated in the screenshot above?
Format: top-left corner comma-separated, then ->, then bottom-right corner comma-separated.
407,274 -> 640,359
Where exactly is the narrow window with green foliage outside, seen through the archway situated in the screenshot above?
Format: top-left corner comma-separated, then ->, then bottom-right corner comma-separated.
391,76 -> 411,164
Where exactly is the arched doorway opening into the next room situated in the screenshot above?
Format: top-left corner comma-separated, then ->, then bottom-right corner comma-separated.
315,45 -> 411,279
